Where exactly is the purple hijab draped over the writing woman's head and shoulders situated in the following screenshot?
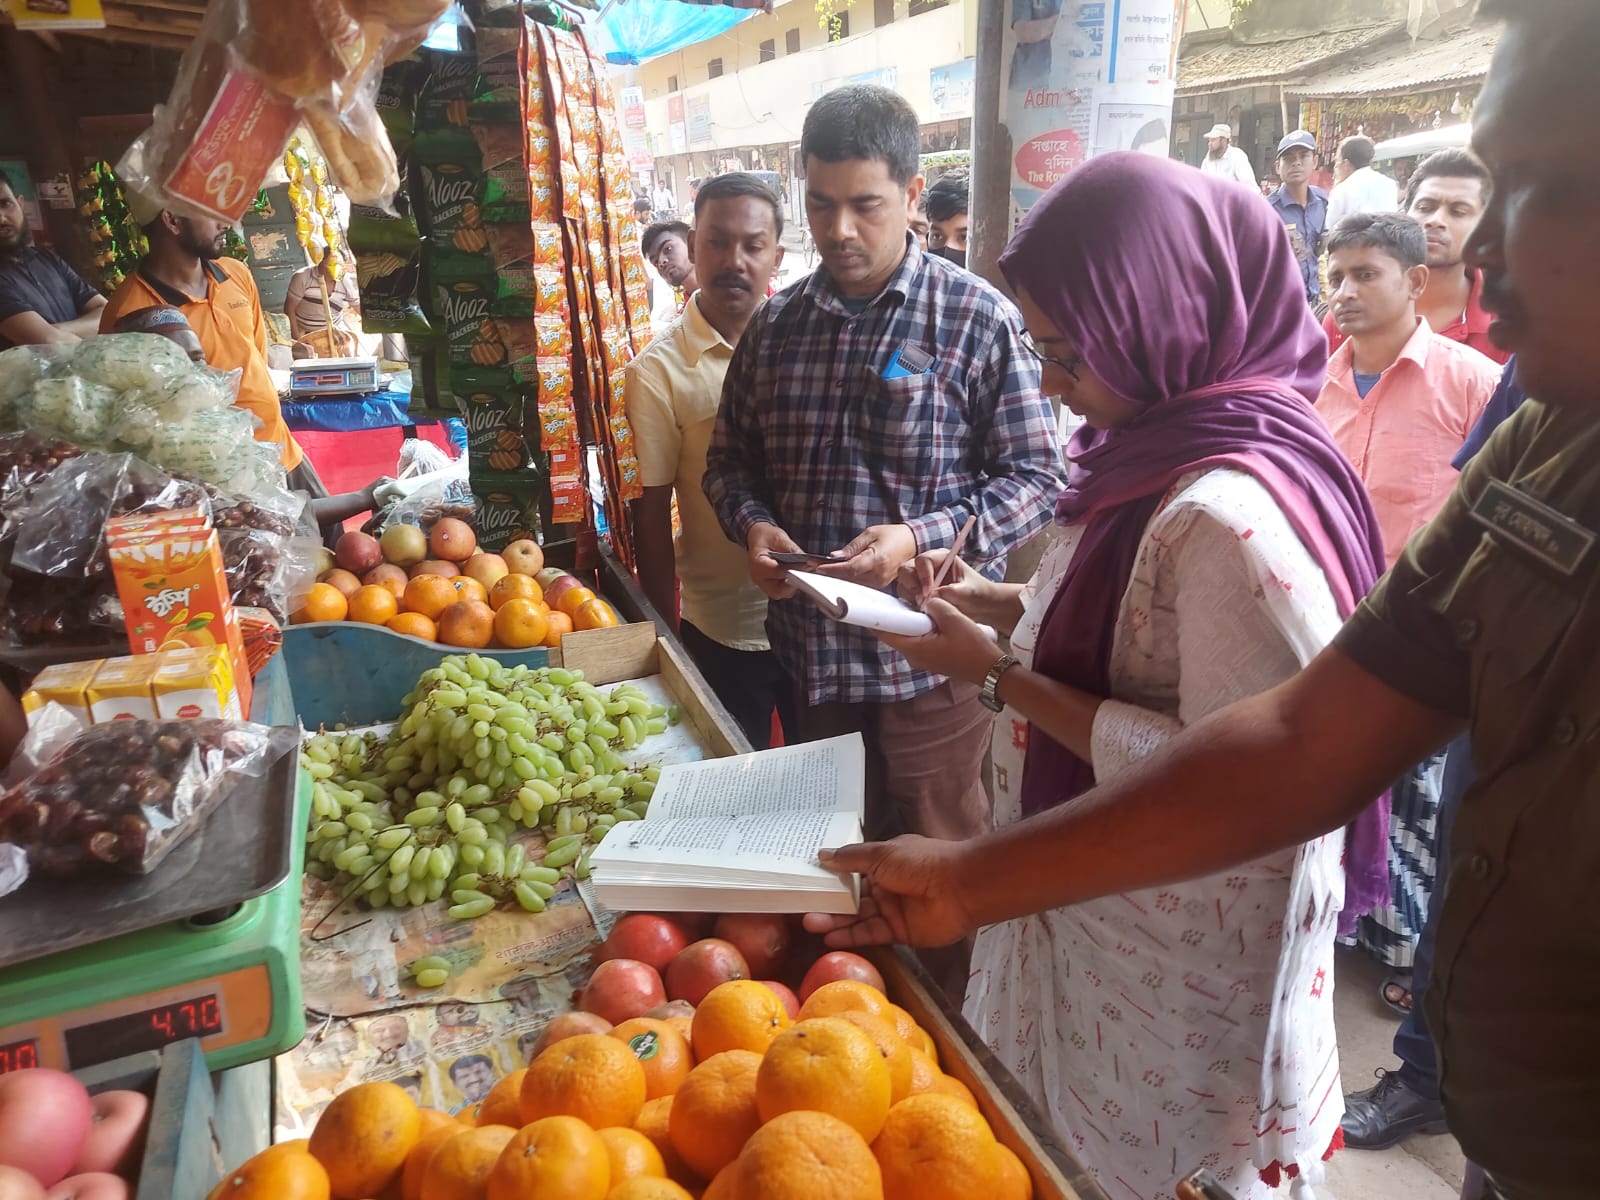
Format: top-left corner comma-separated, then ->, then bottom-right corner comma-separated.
1000,154 -> 1389,928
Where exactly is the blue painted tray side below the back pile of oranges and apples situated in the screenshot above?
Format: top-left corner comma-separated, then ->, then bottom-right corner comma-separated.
280,621 -> 550,730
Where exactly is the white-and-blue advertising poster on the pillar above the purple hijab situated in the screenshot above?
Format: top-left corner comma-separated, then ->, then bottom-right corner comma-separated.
1003,0 -> 1184,226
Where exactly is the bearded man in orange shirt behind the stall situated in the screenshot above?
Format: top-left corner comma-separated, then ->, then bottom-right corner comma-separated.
99,192 -> 318,499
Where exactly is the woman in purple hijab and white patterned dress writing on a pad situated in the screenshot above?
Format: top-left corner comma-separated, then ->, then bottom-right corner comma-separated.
857,154 -> 1386,1200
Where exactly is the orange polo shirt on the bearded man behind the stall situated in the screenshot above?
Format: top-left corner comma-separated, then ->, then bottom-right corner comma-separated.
101,258 -> 306,470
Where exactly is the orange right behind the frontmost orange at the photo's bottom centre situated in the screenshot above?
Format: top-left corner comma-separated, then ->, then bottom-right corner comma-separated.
755,1016 -> 893,1141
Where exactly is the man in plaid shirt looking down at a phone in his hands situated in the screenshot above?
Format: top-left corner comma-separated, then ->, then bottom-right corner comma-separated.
704,86 -> 1064,864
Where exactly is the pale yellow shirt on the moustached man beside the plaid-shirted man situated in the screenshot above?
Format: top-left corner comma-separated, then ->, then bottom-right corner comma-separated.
627,296 -> 768,650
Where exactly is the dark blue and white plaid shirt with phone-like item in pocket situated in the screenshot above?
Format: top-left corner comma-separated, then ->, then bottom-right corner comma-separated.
704,237 -> 1064,704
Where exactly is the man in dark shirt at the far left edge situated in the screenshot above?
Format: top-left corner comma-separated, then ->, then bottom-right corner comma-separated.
0,171 -> 106,350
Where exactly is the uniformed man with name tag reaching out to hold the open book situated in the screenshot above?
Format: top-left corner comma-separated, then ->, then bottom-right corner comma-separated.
806,0 -> 1600,1200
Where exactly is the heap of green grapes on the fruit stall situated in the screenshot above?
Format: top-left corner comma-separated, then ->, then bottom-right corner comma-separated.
301,654 -> 677,920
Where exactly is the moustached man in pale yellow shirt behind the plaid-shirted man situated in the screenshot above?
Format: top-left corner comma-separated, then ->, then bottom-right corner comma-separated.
626,173 -> 794,750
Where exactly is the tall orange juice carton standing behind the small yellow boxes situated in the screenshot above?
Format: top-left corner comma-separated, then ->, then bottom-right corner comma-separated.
106,530 -> 251,712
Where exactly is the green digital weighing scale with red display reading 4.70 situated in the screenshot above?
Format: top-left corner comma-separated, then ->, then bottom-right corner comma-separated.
0,752 -> 310,1074
